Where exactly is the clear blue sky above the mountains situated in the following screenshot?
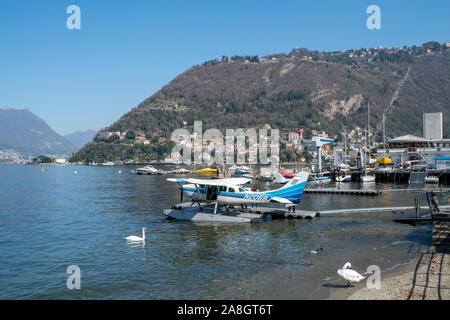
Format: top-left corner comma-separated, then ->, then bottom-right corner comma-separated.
0,0 -> 450,134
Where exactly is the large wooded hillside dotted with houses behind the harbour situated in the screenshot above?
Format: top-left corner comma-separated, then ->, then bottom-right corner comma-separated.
72,41 -> 450,162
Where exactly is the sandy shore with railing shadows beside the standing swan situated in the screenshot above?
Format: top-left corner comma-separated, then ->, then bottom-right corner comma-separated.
330,249 -> 450,300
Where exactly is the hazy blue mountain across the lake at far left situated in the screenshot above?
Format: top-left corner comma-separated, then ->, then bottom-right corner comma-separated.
0,107 -> 77,156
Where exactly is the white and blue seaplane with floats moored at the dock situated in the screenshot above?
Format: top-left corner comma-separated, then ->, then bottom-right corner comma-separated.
163,172 -> 309,222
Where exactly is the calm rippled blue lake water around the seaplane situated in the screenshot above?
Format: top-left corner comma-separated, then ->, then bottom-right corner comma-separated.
0,165 -> 438,299
